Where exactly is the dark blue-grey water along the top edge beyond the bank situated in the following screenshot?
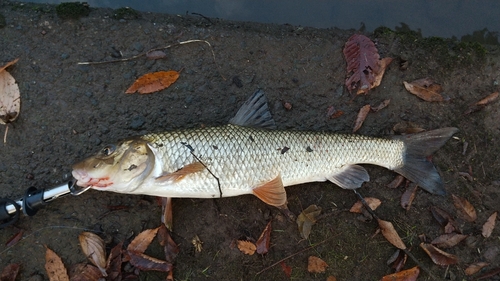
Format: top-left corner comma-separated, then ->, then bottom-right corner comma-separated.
16,0 -> 500,44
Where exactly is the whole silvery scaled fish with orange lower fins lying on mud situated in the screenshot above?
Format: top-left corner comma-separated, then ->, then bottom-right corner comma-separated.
72,90 -> 458,208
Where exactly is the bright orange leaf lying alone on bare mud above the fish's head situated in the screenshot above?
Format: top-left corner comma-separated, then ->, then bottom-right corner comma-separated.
125,70 -> 179,94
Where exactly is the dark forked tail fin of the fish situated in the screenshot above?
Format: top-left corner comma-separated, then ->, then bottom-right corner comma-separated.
394,127 -> 458,195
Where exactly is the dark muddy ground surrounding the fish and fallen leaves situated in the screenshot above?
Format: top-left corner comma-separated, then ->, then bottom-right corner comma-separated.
0,2 -> 500,280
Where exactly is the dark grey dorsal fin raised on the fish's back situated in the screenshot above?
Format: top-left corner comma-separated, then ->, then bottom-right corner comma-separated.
229,89 -> 276,129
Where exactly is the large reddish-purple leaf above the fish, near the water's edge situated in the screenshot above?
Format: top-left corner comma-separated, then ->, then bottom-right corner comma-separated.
343,34 -> 380,95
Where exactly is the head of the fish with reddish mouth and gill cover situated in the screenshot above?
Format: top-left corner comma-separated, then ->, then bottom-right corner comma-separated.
72,139 -> 155,193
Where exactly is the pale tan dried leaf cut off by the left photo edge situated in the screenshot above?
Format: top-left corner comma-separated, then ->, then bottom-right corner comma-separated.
0,59 -> 21,129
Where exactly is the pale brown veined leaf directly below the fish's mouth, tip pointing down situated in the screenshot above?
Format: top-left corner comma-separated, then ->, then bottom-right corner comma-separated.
78,232 -> 108,277
